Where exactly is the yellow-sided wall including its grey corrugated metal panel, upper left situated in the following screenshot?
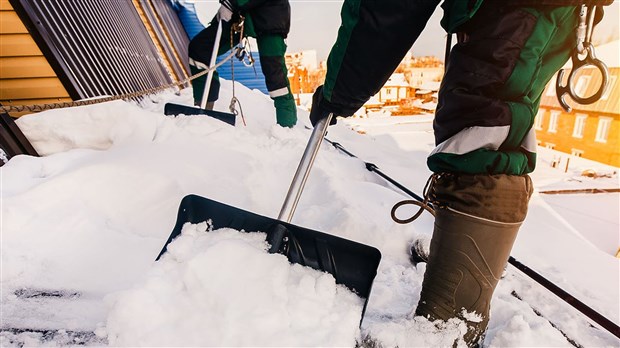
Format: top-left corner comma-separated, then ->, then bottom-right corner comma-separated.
0,0 -> 189,117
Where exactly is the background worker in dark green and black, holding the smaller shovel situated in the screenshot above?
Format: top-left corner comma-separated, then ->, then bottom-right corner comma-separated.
188,0 -> 297,127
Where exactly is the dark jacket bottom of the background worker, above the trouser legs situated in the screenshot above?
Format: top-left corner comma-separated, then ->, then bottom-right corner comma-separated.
220,0 -> 291,38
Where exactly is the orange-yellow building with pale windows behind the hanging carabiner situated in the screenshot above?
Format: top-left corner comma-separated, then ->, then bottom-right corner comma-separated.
534,41 -> 620,167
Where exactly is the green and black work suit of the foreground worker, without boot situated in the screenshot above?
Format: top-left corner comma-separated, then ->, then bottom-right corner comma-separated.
321,0 -> 611,175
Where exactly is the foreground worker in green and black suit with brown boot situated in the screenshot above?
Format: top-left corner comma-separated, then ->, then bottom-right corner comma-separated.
310,0 -> 612,346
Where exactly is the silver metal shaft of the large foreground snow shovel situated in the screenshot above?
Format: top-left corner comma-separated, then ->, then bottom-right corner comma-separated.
278,114 -> 334,222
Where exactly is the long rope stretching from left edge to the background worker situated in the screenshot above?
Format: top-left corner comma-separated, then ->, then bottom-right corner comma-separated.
0,50 -> 236,113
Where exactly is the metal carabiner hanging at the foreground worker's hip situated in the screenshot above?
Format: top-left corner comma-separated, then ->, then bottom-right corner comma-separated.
555,5 -> 609,112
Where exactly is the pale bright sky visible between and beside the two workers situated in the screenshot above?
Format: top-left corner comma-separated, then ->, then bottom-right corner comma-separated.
196,0 -> 620,60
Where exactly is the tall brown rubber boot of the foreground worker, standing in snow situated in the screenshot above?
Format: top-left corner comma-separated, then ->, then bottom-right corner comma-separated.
415,174 -> 532,347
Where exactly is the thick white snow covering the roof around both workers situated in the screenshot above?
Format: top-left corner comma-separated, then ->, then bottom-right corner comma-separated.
0,81 -> 620,347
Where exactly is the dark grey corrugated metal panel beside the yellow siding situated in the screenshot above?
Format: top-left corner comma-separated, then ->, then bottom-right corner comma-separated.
10,0 -> 172,100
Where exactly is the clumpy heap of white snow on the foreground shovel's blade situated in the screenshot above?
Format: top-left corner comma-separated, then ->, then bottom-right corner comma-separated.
106,223 -> 363,347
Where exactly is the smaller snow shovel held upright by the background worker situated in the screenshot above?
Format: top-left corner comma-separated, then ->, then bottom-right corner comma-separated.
164,21 -> 235,126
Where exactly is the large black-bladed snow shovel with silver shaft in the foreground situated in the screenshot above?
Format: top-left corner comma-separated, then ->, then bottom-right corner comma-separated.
157,115 -> 381,325
